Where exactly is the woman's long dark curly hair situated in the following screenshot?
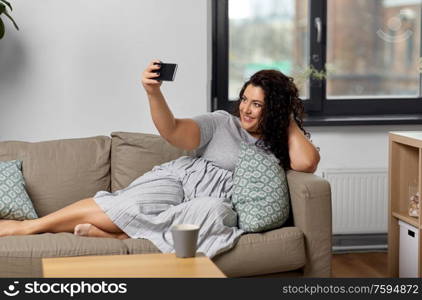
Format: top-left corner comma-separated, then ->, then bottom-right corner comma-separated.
234,70 -> 310,170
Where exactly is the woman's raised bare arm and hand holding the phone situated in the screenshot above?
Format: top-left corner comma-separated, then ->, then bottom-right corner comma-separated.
142,60 -> 201,150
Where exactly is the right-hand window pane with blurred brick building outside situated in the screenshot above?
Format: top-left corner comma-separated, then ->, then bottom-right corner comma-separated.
326,0 -> 422,99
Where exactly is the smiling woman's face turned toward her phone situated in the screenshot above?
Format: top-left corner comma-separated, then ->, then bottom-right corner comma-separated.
239,84 -> 265,138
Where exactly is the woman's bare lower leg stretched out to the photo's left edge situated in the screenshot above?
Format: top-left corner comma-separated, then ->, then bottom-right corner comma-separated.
0,198 -> 122,237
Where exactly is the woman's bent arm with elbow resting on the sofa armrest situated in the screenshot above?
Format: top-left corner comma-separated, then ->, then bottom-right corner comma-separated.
288,119 -> 320,173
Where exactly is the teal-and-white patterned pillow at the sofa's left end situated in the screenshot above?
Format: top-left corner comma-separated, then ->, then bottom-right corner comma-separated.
0,160 -> 38,220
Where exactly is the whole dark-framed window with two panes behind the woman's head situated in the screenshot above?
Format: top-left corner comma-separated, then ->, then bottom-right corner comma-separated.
212,0 -> 422,125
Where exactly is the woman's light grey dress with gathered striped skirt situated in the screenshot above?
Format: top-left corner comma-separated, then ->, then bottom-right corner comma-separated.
94,111 -> 256,258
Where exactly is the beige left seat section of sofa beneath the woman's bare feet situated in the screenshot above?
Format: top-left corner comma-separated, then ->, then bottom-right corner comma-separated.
0,233 -> 127,277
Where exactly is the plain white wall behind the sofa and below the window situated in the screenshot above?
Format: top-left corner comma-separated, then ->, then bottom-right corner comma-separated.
0,0 -> 422,174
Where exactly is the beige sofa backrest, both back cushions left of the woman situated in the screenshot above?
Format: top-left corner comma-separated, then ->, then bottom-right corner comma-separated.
0,132 -> 194,217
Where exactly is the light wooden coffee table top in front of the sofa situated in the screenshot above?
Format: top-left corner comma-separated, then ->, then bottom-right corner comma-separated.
42,253 -> 226,278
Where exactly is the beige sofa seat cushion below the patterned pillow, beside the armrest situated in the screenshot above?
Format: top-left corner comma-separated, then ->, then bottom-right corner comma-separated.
213,227 -> 306,277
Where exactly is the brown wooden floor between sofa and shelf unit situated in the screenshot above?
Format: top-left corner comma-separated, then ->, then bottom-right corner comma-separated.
332,252 -> 388,278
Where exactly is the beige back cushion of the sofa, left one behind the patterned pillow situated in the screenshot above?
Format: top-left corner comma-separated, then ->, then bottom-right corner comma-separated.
0,136 -> 111,217
